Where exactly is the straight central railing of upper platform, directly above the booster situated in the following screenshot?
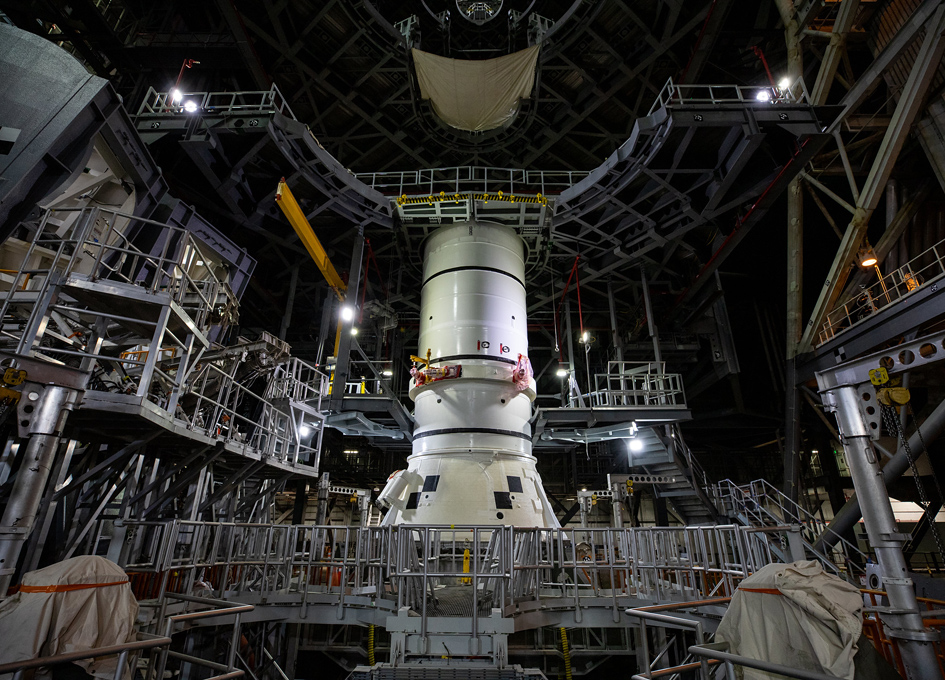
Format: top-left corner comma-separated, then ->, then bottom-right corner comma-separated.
355,165 -> 588,196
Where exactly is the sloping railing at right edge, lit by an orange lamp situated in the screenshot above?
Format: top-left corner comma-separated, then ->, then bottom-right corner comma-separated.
817,240 -> 945,347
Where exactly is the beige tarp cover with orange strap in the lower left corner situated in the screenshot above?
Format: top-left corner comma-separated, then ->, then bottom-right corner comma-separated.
0,556 -> 138,678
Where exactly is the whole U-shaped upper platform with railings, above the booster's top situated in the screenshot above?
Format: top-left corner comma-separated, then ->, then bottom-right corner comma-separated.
135,79 -> 837,302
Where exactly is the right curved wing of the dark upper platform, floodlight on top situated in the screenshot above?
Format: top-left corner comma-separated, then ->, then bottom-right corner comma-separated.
554,86 -> 837,275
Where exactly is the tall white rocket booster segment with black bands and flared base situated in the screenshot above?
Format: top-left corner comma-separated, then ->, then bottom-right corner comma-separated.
378,223 -> 558,527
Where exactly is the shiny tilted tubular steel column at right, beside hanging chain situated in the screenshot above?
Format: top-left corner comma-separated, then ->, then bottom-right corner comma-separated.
825,385 -> 941,680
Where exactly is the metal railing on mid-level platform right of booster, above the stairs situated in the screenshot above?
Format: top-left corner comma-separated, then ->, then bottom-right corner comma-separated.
571,361 -> 686,407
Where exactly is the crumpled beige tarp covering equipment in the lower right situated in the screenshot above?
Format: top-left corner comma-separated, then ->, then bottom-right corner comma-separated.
715,561 -> 863,680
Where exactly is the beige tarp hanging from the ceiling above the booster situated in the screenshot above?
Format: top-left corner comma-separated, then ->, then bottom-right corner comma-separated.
412,45 -> 540,131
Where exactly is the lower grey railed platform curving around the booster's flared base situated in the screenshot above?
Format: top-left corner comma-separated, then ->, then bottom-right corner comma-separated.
97,508 -> 900,677
